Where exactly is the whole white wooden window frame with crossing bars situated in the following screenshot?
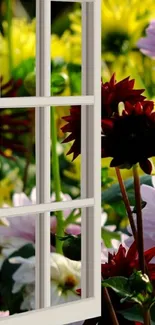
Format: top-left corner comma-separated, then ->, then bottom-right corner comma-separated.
0,0 -> 101,325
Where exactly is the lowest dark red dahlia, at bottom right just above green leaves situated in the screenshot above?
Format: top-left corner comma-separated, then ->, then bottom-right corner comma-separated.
101,242 -> 155,281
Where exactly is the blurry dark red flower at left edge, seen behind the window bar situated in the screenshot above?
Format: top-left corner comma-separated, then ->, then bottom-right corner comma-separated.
0,76 -> 33,159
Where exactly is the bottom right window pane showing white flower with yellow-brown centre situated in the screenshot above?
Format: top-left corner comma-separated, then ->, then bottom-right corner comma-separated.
51,209 -> 81,306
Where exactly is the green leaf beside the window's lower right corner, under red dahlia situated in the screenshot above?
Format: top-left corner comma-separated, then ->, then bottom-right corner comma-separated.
102,276 -> 131,297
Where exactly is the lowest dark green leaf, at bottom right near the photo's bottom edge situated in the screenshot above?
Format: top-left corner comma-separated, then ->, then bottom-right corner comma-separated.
118,305 -> 143,322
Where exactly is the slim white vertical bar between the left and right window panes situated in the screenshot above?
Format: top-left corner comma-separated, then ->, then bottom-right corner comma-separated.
35,0 -> 51,309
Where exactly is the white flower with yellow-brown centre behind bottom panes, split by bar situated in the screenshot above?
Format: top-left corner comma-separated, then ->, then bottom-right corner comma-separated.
9,253 -> 81,310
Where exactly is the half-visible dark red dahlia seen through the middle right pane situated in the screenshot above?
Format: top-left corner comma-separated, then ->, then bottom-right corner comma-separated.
61,106 -> 81,160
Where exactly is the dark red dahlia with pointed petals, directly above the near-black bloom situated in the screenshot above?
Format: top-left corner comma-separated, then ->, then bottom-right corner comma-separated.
101,73 -> 145,118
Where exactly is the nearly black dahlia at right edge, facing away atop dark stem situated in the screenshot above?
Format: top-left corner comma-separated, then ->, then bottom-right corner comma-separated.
102,101 -> 155,174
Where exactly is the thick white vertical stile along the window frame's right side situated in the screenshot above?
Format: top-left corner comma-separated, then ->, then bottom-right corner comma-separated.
81,1 -> 101,308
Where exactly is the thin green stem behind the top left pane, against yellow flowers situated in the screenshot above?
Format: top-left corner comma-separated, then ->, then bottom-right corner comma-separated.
6,0 -> 13,77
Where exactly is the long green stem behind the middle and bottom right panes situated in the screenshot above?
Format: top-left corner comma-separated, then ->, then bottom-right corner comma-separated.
51,107 -> 64,254
